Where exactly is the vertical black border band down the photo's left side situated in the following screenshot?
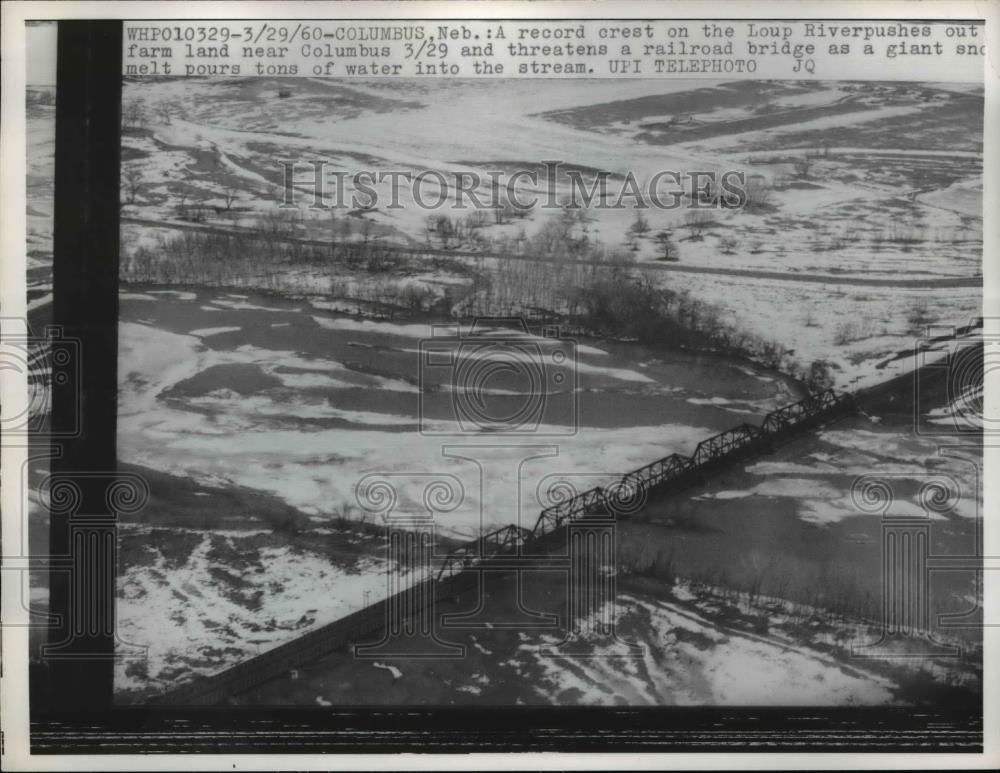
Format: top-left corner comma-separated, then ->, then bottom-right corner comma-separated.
43,21 -> 123,708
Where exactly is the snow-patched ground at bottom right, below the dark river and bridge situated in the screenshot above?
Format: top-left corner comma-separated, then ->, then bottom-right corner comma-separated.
234,579 -> 977,706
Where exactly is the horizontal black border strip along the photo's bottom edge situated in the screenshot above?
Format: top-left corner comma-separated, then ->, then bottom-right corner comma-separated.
31,706 -> 983,754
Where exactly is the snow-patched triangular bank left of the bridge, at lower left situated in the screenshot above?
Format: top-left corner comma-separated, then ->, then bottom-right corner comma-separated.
115,524 -> 386,700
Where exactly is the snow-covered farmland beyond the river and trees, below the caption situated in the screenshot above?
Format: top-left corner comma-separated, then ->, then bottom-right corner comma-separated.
124,79 -> 982,388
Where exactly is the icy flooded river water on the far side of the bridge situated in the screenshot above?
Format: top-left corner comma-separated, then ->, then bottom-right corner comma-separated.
119,288 -> 793,536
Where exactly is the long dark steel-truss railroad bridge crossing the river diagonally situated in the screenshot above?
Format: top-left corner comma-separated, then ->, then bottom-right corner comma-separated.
154,389 -> 855,705
